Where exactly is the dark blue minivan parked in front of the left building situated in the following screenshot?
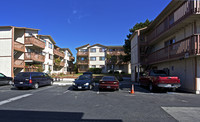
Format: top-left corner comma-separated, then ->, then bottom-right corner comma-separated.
14,72 -> 53,89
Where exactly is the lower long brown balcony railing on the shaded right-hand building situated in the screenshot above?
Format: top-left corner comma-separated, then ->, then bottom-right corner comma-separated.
146,35 -> 200,64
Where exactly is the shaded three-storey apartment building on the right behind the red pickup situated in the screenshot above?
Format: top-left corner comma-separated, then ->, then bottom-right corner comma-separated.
131,0 -> 200,94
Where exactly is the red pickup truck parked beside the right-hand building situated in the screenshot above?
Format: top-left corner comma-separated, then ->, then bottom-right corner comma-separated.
139,70 -> 181,91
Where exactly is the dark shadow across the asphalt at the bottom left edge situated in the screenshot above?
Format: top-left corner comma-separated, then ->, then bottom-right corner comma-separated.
0,110 -> 122,122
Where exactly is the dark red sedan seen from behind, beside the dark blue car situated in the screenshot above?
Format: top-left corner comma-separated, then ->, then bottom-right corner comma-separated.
99,76 -> 119,90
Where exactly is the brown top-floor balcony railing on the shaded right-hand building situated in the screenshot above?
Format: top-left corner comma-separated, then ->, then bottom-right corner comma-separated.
147,0 -> 197,43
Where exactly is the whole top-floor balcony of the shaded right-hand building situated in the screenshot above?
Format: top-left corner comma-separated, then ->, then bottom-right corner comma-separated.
147,0 -> 200,44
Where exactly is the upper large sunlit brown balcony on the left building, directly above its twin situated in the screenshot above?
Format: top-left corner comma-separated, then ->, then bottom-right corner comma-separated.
25,37 -> 45,49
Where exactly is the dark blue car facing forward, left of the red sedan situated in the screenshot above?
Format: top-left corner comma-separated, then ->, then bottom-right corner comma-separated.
73,75 -> 93,89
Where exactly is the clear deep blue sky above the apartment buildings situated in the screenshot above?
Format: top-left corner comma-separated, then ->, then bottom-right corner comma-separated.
0,0 -> 171,56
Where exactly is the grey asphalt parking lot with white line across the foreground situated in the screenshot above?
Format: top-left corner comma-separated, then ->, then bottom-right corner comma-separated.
0,82 -> 200,122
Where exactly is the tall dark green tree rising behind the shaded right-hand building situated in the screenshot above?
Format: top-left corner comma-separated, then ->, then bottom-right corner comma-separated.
123,19 -> 152,62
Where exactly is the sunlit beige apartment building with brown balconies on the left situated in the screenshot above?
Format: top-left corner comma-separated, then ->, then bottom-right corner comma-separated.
0,26 -> 73,77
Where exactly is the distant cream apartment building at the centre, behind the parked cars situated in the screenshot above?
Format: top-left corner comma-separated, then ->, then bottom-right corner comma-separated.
76,44 -> 130,73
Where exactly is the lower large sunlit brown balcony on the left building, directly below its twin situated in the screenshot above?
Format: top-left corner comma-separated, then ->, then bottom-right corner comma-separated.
24,52 -> 45,62
